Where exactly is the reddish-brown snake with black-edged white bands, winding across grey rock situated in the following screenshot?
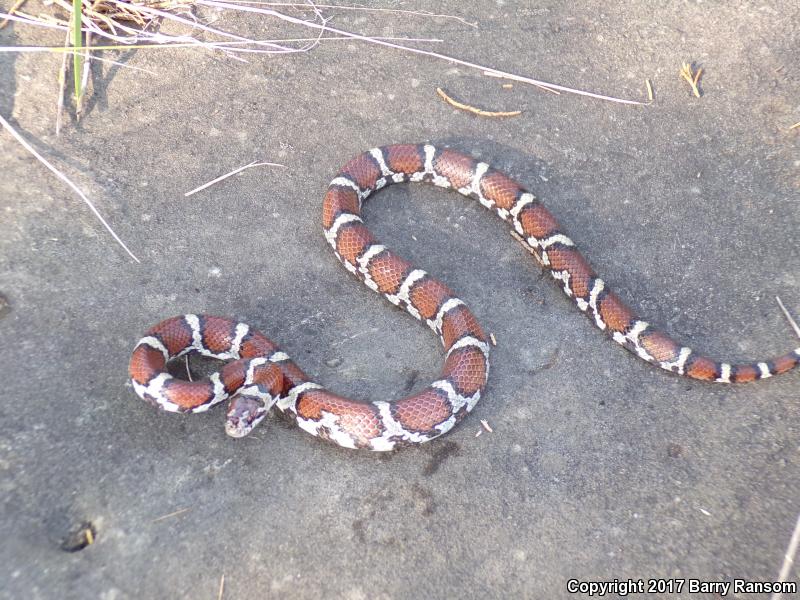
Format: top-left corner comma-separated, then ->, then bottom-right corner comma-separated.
129,144 -> 800,451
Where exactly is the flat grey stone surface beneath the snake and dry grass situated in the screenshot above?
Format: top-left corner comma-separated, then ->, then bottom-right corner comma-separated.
0,0 -> 800,600
